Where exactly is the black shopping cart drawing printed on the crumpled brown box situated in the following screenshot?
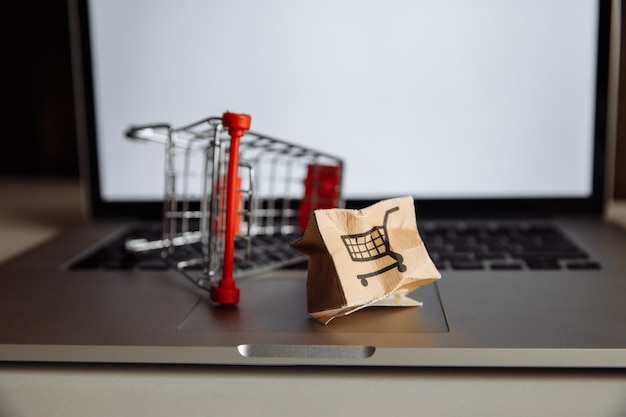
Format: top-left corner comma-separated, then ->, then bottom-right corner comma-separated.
341,206 -> 406,287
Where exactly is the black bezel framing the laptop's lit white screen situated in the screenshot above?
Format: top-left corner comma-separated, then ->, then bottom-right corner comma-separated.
68,0 -> 612,219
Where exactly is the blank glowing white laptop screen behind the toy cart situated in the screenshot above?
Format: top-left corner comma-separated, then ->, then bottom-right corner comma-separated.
74,0 -> 604,216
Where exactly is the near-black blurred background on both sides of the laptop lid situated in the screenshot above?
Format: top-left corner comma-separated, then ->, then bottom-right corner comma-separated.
0,0 -> 626,198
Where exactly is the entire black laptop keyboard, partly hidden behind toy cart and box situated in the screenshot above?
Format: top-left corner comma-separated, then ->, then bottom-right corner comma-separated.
72,222 -> 601,276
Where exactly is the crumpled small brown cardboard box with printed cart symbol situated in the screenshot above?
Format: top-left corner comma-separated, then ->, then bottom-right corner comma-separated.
292,197 -> 441,324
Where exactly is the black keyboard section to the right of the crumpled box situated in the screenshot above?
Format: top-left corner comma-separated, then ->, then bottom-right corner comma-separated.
419,223 -> 600,271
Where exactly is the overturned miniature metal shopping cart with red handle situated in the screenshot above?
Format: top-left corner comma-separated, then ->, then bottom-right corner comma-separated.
126,112 -> 343,304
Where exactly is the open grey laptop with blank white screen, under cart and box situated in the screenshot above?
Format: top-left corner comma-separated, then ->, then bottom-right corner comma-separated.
0,0 -> 626,368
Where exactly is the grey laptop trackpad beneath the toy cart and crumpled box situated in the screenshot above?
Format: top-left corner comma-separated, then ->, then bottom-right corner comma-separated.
179,271 -> 448,334
